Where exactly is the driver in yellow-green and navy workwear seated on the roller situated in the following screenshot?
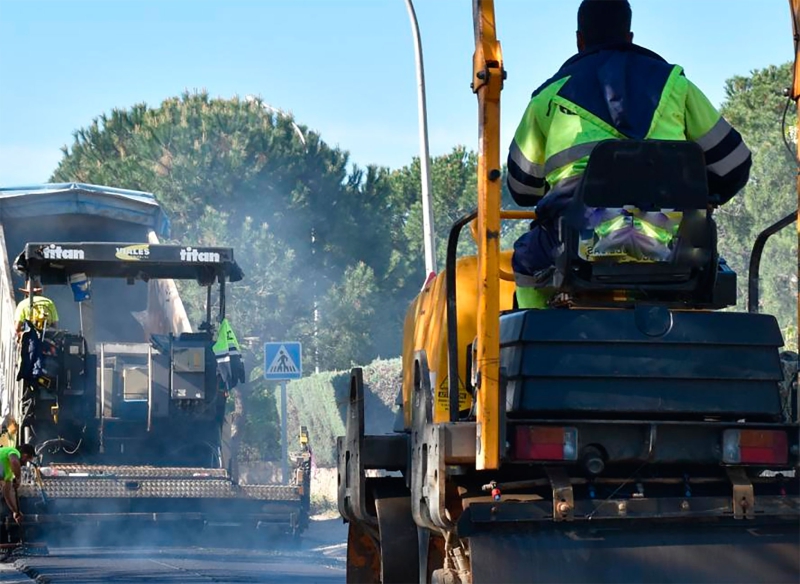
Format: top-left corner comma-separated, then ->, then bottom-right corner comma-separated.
508,0 -> 751,308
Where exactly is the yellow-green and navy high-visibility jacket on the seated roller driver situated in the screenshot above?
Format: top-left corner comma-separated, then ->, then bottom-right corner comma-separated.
508,43 -> 751,216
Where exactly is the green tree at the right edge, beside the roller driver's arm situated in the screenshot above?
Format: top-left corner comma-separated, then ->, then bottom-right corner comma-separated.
717,63 -> 797,344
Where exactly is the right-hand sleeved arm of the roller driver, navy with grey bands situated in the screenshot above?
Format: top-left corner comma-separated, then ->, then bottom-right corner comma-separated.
686,81 -> 752,205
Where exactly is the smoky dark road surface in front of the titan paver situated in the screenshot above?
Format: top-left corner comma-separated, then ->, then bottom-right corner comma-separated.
0,519 -> 346,584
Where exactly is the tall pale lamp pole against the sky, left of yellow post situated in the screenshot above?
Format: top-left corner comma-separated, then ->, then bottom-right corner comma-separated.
405,0 -> 436,278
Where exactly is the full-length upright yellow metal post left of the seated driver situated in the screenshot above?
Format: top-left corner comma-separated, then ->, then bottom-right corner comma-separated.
472,0 -> 505,470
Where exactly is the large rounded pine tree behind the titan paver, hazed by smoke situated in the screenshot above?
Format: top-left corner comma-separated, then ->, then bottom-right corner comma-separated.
53,93 -> 395,368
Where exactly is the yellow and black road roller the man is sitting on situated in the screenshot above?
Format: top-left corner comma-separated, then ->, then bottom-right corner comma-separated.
337,0 -> 800,584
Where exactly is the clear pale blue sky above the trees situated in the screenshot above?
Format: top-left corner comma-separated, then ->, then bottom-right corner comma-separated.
0,0 -> 792,186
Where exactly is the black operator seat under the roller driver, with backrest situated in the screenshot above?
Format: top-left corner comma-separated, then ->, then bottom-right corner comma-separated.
548,140 -> 736,308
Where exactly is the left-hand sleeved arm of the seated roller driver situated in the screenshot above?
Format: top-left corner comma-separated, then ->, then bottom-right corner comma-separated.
508,98 -> 547,207
